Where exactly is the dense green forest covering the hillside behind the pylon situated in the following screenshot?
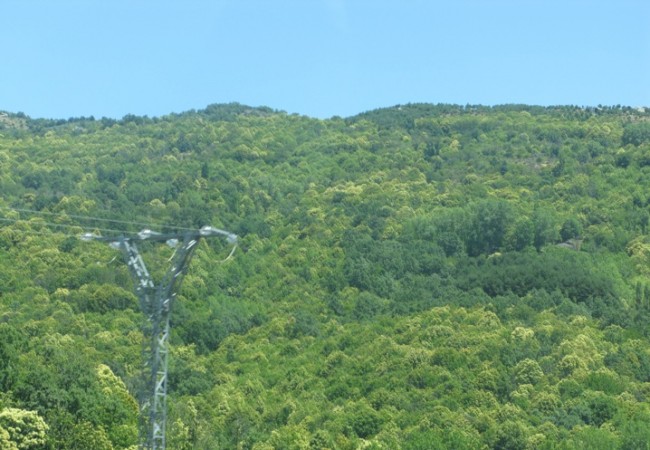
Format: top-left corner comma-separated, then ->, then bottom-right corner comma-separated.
0,104 -> 650,450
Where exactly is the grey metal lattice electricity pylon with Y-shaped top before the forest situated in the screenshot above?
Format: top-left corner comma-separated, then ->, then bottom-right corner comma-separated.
81,226 -> 237,450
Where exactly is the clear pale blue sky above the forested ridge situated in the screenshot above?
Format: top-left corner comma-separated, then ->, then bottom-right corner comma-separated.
0,0 -> 650,119
